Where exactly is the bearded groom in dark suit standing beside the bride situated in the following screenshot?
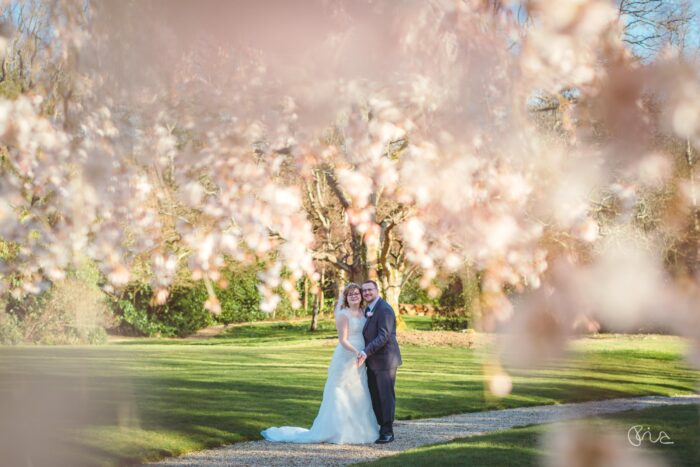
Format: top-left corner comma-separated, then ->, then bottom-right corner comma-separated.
357,281 -> 401,444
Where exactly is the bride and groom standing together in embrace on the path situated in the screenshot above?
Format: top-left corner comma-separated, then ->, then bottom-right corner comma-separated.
261,281 -> 401,444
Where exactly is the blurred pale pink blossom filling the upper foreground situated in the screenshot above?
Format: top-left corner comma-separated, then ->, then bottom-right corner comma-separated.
0,0 -> 700,464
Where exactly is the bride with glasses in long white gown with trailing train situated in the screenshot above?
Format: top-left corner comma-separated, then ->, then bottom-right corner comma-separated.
261,283 -> 379,444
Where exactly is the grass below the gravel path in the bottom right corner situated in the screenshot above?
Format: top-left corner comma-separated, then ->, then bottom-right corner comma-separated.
356,405 -> 700,467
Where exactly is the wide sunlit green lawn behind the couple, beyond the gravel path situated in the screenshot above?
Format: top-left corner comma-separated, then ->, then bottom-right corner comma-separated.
0,324 -> 698,464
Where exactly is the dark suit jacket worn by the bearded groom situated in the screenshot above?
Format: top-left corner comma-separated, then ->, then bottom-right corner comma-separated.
362,298 -> 402,370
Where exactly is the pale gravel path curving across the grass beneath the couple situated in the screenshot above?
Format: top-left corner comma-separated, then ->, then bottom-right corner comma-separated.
150,395 -> 700,467
